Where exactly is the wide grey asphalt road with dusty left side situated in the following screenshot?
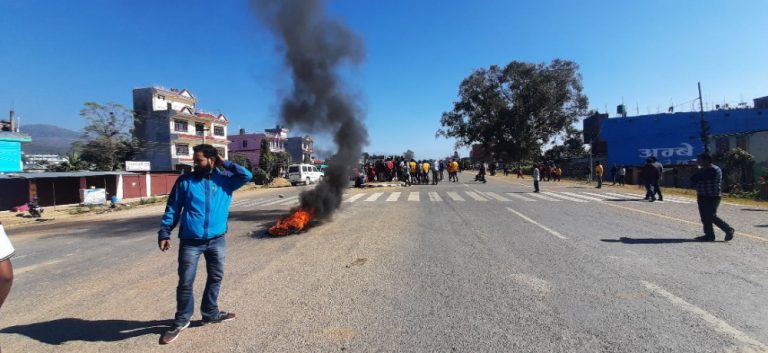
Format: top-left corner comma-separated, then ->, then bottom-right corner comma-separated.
0,173 -> 768,352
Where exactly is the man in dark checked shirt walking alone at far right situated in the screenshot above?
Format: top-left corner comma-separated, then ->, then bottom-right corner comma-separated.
691,152 -> 736,241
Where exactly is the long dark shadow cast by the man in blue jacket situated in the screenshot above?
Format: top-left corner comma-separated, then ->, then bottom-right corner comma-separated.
0,318 -> 172,345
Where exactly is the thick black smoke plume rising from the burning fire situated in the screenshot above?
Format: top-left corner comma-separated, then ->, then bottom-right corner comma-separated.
253,0 -> 368,219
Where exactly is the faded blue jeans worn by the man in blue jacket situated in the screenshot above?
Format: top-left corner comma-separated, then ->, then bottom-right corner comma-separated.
174,236 -> 227,326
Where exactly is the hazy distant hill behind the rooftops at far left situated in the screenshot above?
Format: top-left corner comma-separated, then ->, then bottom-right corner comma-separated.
21,124 -> 82,155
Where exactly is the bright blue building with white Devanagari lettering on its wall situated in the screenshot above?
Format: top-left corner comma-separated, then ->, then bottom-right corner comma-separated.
583,104 -> 768,166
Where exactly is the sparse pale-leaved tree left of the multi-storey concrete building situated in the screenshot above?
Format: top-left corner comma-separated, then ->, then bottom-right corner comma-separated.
77,102 -> 136,170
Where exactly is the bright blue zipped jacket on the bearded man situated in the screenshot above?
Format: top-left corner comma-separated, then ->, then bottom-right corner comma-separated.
157,161 -> 253,240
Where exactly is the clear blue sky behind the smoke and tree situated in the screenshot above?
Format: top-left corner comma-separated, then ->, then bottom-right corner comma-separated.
0,0 -> 768,158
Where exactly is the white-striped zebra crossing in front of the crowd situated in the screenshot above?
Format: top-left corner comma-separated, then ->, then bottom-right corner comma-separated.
231,189 -> 695,209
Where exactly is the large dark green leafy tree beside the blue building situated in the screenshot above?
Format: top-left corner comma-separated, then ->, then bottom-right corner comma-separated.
437,59 -> 588,160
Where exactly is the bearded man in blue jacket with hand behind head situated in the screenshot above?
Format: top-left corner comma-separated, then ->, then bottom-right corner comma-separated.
158,144 -> 253,344
